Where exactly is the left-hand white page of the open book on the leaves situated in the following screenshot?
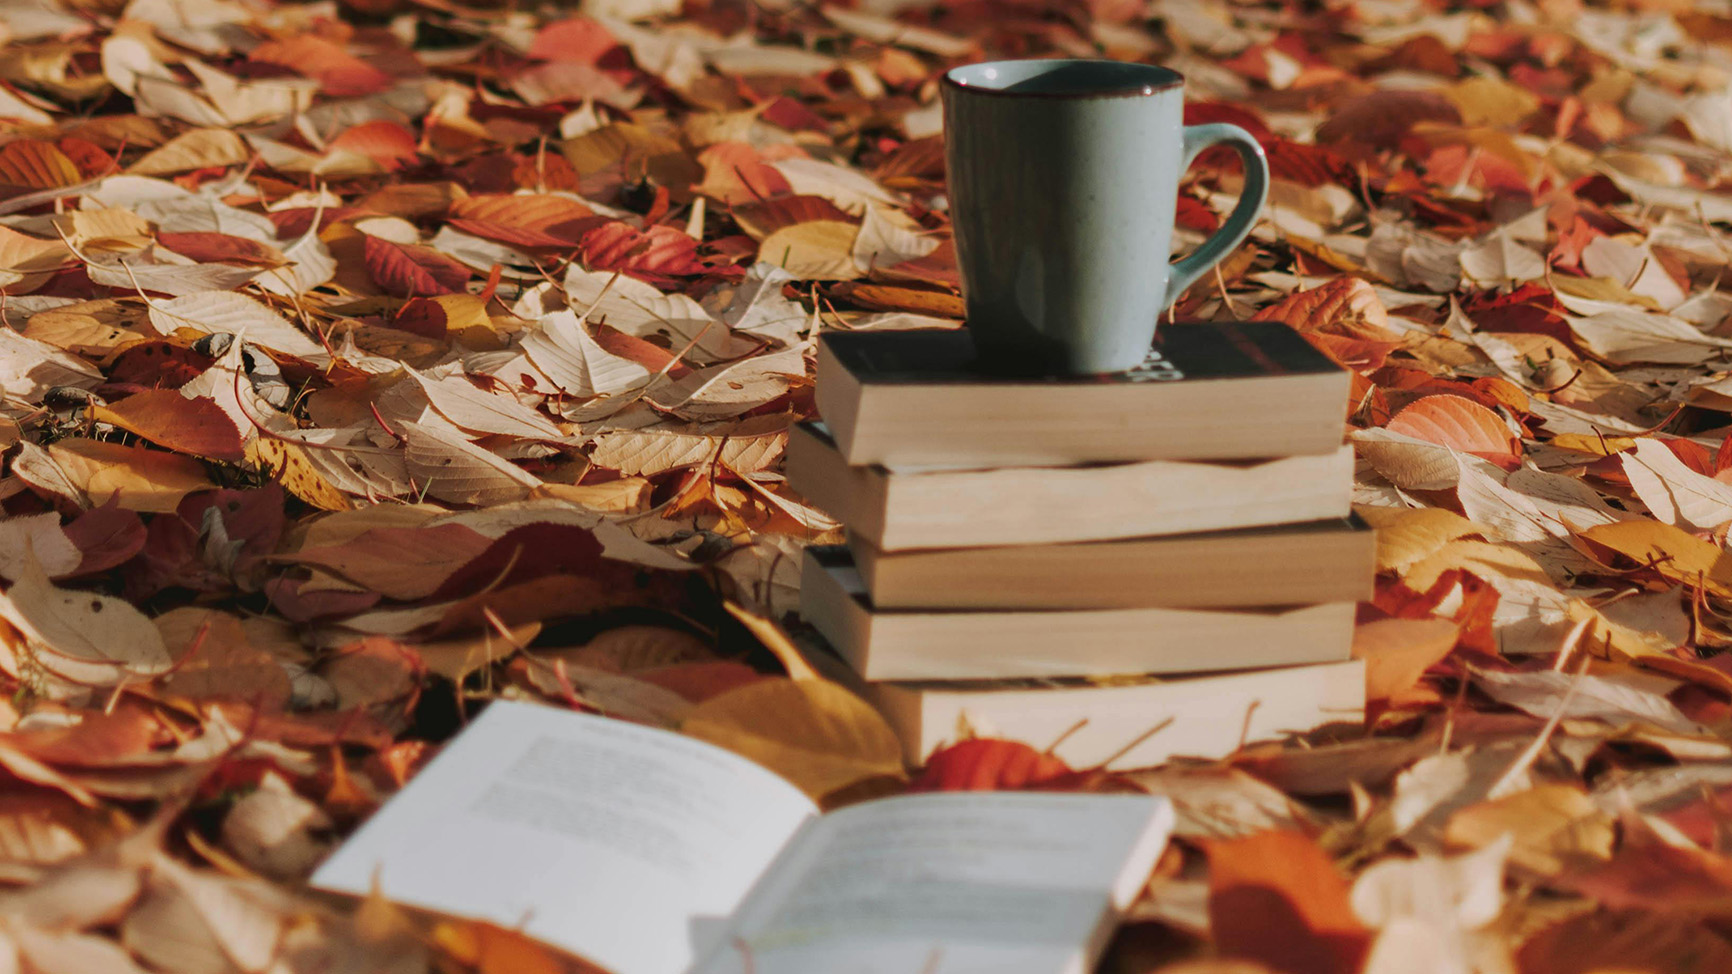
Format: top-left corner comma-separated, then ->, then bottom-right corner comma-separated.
312,702 -> 818,974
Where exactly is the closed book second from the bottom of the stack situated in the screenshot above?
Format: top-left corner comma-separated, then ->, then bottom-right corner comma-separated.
800,544 -> 1356,679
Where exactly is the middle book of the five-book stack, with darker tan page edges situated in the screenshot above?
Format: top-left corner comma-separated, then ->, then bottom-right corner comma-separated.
849,516 -> 1377,610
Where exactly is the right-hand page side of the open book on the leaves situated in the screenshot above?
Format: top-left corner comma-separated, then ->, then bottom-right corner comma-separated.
698,792 -> 1173,974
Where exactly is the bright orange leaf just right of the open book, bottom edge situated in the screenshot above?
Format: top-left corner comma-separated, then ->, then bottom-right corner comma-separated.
1205,830 -> 1370,974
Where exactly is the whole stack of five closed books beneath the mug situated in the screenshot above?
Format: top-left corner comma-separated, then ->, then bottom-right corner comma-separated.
786,322 -> 1375,768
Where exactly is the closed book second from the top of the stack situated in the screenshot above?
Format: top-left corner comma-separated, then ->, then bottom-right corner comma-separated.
783,423 -> 1353,551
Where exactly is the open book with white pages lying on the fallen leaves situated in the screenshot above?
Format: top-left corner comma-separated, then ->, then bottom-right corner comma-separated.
312,702 -> 1173,974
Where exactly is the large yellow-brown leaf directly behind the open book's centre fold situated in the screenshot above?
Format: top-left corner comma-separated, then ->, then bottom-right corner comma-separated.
681,679 -> 904,799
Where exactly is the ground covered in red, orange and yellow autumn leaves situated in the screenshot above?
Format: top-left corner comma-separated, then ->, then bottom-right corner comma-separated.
0,0 -> 1732,974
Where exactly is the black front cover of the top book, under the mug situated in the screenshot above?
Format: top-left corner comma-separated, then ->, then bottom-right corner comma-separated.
821,321 -> 1341,385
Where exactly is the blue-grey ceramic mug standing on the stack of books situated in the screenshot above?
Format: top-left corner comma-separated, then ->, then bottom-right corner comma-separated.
942,61 -> 1270,374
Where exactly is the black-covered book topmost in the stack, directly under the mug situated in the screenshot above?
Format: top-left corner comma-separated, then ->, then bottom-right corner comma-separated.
818,321 -> 1349,466
